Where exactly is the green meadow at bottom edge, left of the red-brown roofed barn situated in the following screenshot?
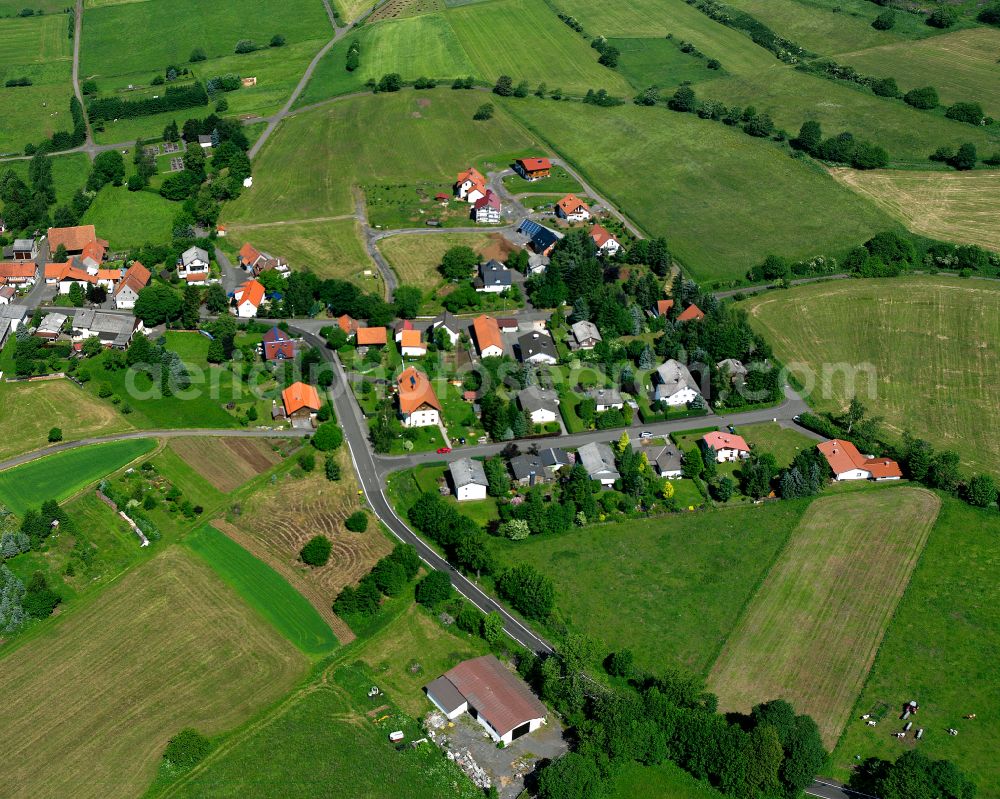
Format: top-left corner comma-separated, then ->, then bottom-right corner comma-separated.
160,609 -> 482,799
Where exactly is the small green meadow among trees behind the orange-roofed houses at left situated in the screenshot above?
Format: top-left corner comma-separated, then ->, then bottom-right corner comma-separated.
80,185 -> 181,250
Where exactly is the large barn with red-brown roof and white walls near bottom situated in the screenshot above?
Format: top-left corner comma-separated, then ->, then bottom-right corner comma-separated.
424,655 -> 547,744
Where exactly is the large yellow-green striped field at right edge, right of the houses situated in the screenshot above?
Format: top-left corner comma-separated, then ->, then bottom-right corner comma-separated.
746,277 -> 1000,474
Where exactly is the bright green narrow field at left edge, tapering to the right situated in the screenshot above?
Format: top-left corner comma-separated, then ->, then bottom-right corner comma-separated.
0,438 -> 156,515
